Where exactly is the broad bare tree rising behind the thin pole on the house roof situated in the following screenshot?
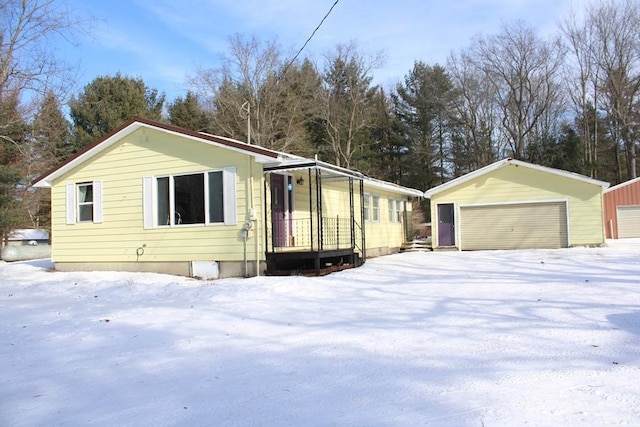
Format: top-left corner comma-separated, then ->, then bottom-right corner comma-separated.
190,35 -> 319,151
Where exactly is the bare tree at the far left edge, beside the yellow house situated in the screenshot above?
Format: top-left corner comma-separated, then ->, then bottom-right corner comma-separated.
0,0 -> 82,232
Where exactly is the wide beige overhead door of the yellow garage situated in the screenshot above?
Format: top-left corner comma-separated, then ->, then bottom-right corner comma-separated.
460,202 -> 569,250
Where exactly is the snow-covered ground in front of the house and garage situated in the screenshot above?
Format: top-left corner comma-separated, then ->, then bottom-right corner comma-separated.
0,240 -> 640,426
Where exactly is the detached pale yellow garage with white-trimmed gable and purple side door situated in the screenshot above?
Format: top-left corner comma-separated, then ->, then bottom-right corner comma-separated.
425,159 -> 609,250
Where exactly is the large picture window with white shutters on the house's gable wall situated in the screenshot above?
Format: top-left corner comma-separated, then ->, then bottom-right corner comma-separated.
145,168 -> 236,228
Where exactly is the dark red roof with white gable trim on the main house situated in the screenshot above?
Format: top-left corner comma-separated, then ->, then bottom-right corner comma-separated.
32,117 -> 280,188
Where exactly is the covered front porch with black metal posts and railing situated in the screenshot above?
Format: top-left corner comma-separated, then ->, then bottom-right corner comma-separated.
264,159 -> 366,275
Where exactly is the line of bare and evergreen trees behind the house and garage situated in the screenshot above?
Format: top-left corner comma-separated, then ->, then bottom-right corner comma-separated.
0,0 -> 640,239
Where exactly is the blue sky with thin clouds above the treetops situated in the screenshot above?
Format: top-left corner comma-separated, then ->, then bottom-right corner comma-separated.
61,0 -> 582,101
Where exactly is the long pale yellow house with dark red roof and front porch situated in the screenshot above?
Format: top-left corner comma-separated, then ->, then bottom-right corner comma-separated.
33,119 -> 422,278
